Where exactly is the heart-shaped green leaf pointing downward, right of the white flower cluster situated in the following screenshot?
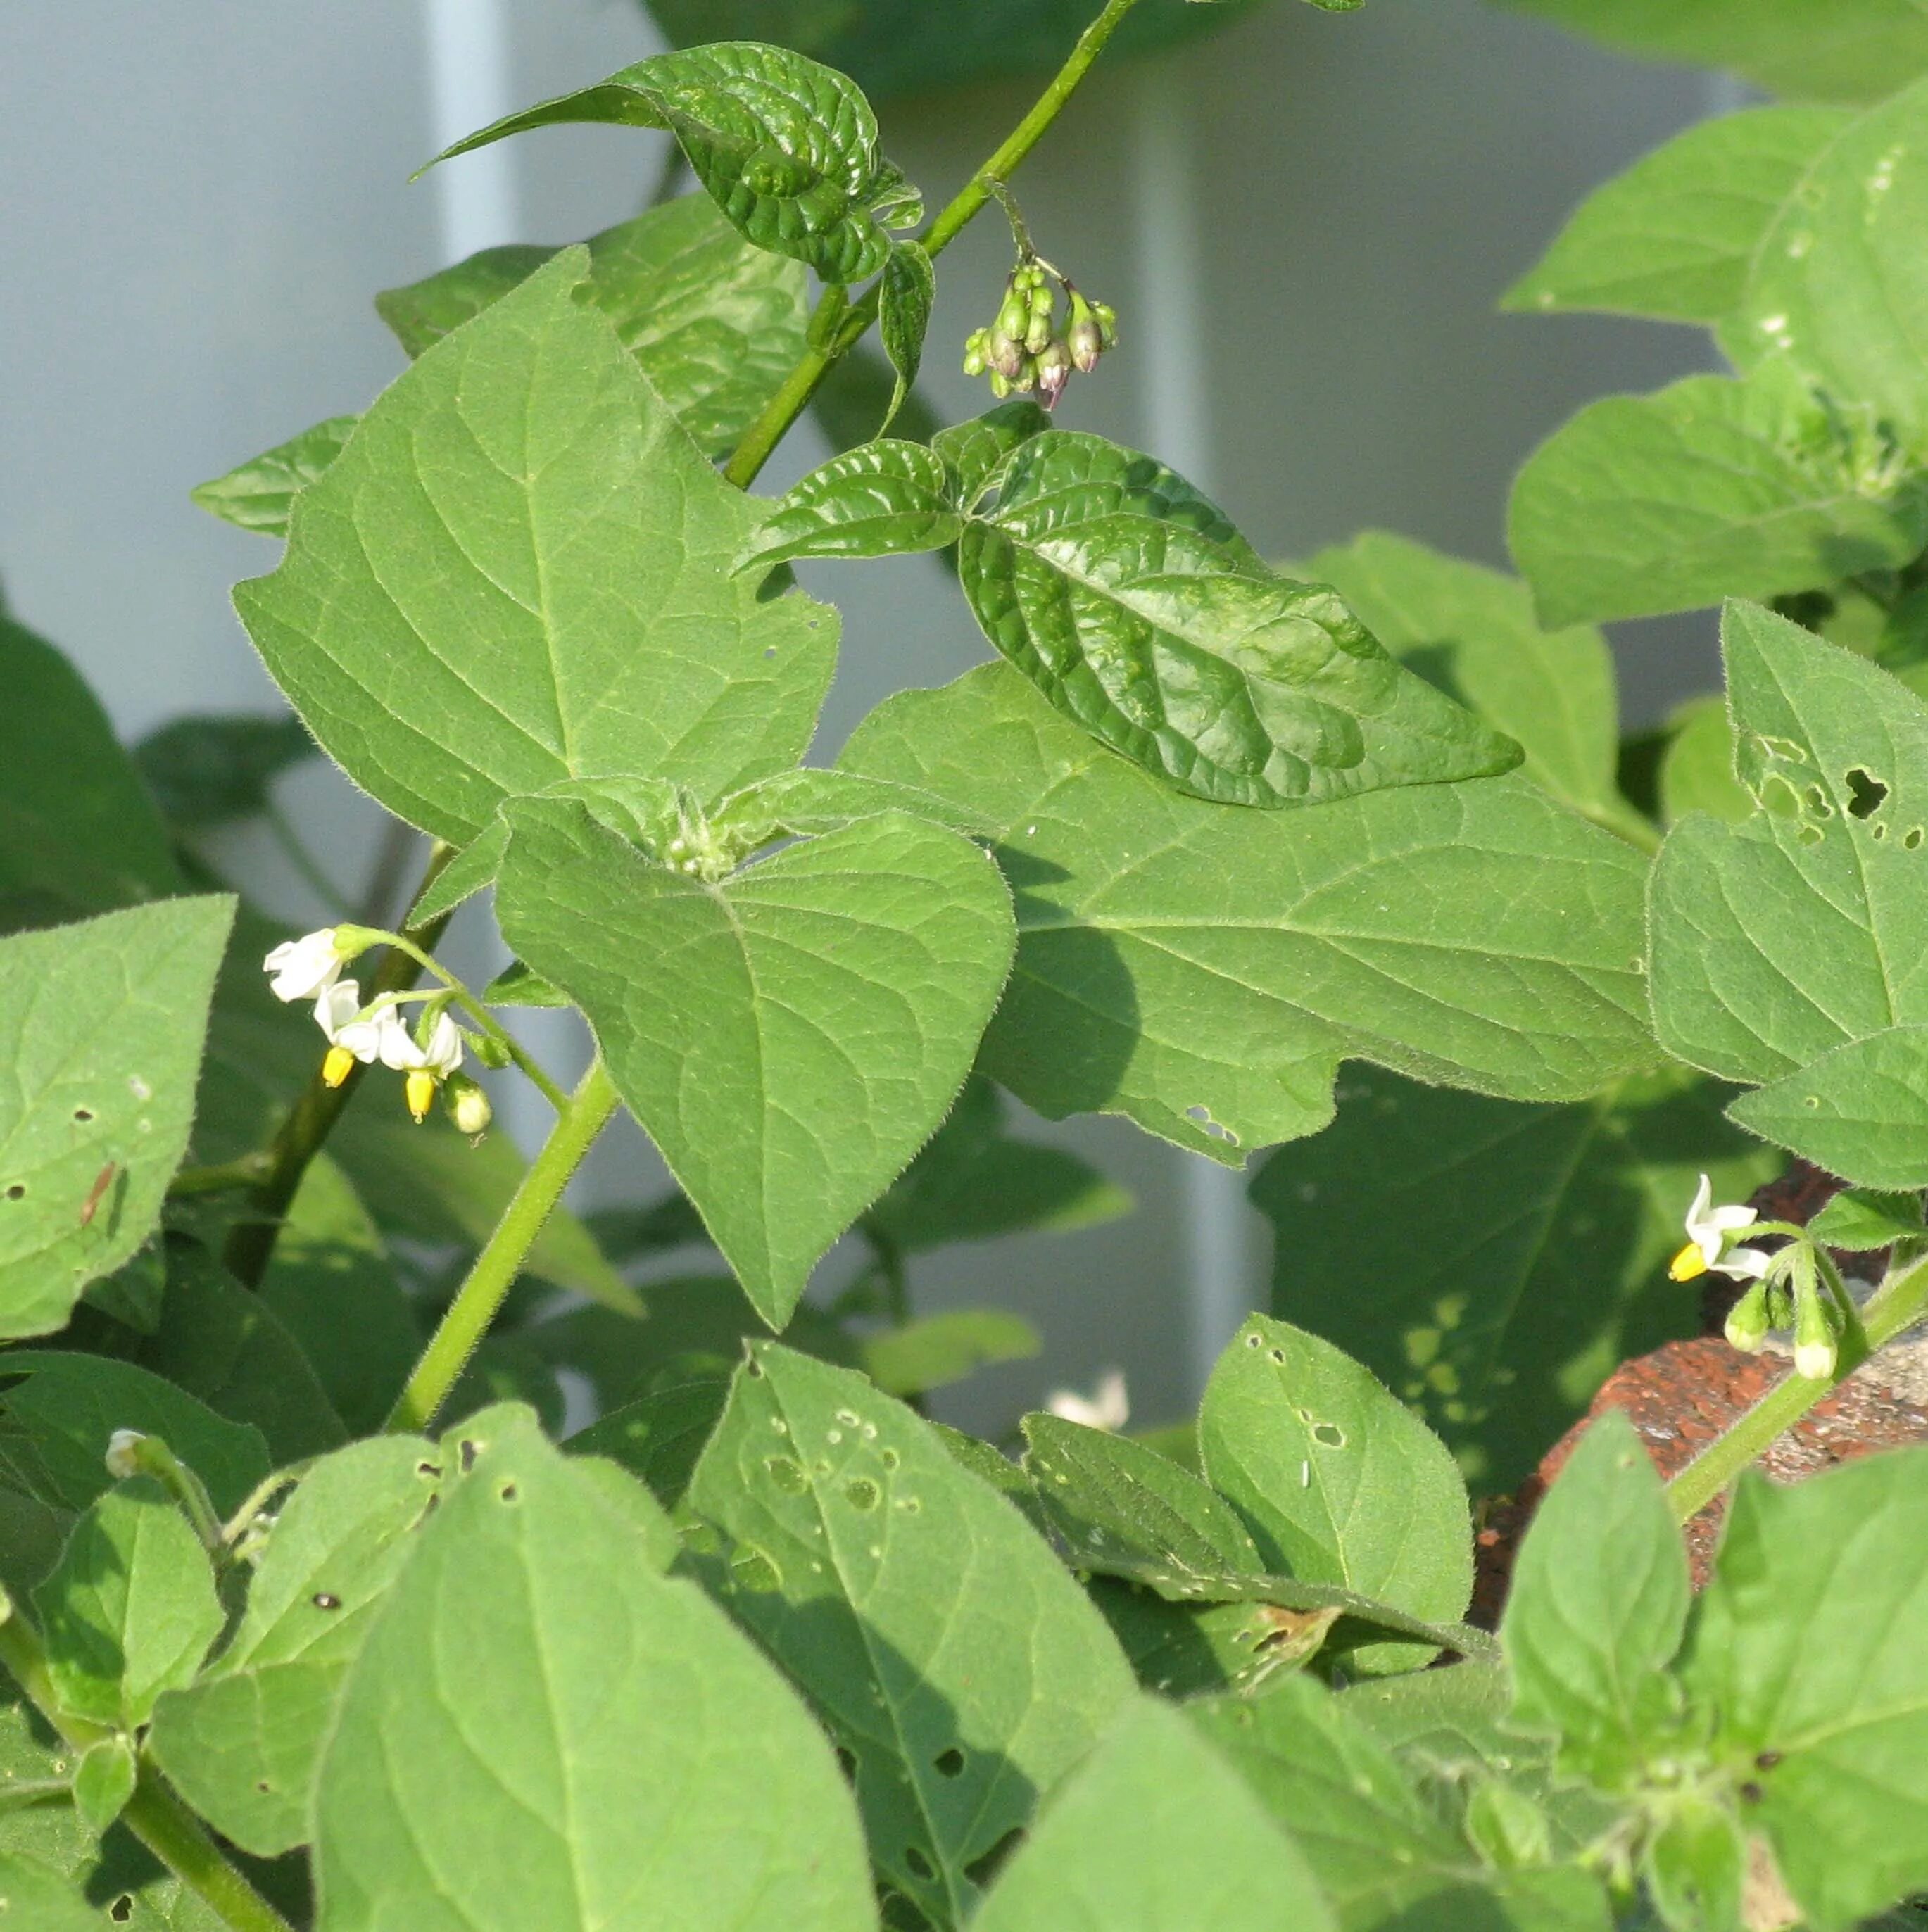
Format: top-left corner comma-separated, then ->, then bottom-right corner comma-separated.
496,800 -> 1012,1323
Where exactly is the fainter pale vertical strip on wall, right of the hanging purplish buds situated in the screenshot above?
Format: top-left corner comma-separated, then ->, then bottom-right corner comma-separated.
1124,60 -> 1252,1389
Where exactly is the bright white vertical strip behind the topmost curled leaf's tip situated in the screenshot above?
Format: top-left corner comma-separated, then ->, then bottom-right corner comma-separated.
421,0 -> 518,261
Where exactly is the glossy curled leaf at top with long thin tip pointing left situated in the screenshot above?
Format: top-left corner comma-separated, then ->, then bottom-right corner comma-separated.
436,41 -> 916,282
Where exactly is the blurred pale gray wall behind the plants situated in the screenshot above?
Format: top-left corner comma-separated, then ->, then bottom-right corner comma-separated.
0,0 -> 1731,1428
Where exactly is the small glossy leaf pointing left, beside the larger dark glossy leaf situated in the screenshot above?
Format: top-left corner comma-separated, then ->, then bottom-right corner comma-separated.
738,441 -> 964,570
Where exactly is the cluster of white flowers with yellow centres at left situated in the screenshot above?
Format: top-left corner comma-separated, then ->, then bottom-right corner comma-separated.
263,926 -> 491,1136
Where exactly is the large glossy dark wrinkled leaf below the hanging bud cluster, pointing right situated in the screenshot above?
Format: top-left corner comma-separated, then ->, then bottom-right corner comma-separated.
958,429 -> 1520,807
